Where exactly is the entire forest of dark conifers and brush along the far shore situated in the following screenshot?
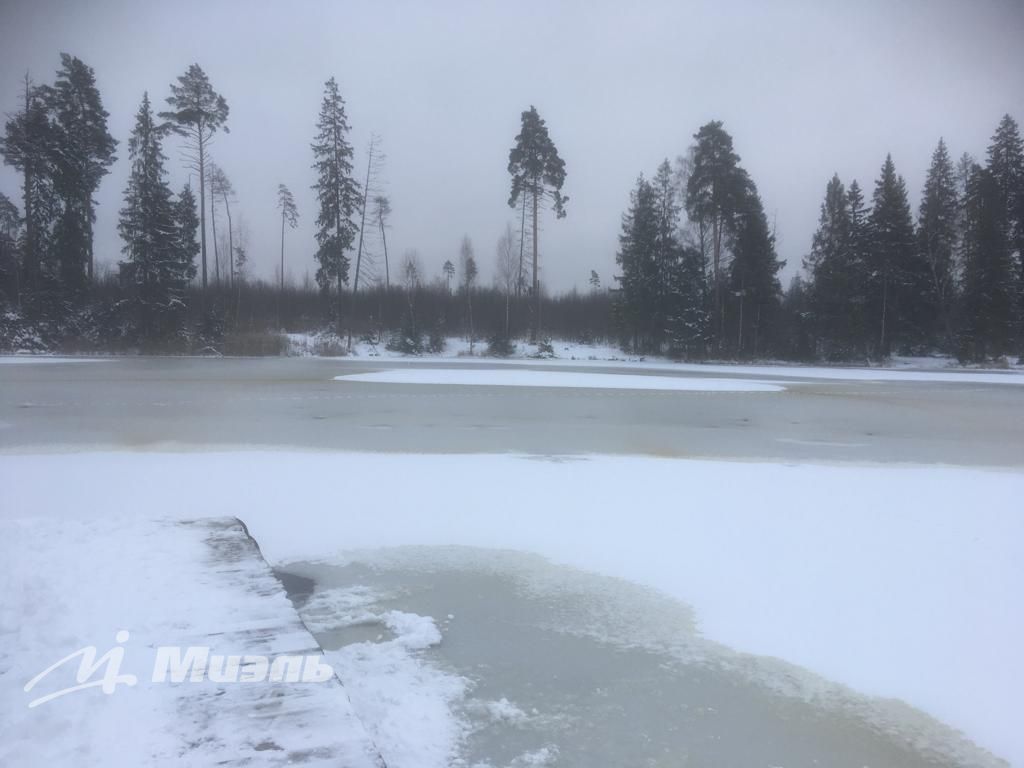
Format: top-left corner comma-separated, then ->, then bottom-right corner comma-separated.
0,53 -> 1024,362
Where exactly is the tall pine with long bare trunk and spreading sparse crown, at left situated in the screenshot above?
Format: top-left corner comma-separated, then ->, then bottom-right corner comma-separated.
160,63 -> 229,294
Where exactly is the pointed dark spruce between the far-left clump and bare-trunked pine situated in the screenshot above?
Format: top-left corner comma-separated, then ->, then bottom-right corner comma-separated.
118,94 -> 195,342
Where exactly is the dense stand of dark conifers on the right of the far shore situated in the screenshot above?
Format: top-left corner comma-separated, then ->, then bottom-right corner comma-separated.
614,115 -> 1024,361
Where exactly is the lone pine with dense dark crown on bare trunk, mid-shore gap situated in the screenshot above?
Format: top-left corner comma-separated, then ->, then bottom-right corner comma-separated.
509,106 -> 568,339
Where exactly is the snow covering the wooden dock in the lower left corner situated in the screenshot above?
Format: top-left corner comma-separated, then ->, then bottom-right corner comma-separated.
0,514 -> 377,768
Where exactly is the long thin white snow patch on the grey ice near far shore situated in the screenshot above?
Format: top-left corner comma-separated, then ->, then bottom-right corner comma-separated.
334,368 -> 785,392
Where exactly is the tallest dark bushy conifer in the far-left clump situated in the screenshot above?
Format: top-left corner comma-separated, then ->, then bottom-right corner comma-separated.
43,53 -> 118,295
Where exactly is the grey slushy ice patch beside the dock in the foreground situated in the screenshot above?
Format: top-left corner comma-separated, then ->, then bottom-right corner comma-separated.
279,548 -> 991,768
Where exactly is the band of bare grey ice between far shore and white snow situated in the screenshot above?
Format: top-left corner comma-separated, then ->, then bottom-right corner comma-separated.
0,358 -> 1024,467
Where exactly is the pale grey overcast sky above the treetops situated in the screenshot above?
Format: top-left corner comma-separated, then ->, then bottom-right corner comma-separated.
0,0 -> 1024,290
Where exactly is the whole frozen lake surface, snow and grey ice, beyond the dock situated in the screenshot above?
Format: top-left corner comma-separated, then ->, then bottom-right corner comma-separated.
0,358 -> 1024,768
